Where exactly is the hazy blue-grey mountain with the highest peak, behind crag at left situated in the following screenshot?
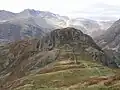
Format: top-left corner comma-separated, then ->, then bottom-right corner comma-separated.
0,9 -> 68,41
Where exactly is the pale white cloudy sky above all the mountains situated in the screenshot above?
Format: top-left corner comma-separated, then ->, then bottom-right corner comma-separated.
0,0 -> 120,20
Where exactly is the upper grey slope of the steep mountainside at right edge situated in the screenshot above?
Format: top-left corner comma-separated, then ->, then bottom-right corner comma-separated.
96,20 -> 120,48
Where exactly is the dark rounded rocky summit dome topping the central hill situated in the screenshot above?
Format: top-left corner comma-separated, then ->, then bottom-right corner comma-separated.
42,27 -> 101,50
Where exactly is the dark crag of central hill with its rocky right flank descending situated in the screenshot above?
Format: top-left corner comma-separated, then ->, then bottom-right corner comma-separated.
41,28 -> 116,67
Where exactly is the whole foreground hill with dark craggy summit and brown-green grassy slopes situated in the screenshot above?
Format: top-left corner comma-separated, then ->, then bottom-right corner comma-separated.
0,27 -> 118,90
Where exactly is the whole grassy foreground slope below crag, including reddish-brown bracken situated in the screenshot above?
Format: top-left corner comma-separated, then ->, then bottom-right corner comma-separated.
1,44 -> 120,90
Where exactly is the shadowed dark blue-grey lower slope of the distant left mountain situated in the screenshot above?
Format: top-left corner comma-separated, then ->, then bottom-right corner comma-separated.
0,22 -> 45,41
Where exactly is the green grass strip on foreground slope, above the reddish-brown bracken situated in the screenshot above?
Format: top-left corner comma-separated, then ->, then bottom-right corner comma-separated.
12,60 -> 114,90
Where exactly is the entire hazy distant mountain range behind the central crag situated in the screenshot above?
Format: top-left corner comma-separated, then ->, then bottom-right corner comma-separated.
0,9 -> 114,41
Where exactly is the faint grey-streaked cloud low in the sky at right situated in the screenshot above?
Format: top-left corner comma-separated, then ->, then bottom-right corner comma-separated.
70,3 -> 120,20
